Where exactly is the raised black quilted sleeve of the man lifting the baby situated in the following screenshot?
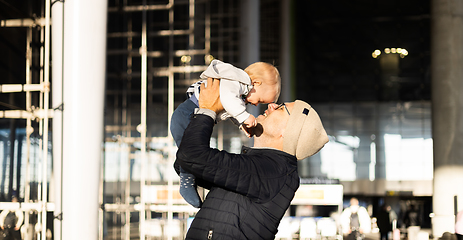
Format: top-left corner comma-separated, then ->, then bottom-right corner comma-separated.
176,115 -> 286,201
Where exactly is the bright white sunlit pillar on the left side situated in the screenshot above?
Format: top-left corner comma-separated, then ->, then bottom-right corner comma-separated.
62,0 -> 108,240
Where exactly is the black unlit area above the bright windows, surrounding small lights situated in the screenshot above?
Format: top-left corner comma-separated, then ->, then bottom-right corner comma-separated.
295,0 -> 431,102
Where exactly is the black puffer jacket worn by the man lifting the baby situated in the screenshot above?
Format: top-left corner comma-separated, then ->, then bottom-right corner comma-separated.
175,115 -> 299,240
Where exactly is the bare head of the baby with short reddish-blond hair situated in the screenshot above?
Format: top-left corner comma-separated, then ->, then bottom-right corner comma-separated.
244,62 -> 281,106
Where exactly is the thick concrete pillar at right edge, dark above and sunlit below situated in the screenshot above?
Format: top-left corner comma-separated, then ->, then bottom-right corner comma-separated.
431,0 -> 463,238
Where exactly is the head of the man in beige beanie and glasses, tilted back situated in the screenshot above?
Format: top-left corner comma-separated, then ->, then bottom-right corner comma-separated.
254,100 -> 328,160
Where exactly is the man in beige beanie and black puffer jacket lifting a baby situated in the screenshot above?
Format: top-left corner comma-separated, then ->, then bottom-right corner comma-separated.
175,79 -> 328,240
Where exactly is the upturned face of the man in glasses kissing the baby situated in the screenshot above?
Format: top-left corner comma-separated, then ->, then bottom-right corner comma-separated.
254,102 -> 294,137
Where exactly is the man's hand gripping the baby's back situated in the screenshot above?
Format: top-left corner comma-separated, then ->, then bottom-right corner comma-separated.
198,78 -> 223,113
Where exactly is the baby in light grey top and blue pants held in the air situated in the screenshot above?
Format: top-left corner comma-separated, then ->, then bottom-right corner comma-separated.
170,59 -> 281,208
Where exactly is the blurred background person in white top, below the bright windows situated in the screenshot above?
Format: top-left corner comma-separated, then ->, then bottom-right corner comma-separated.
340,198 -> 371,240
